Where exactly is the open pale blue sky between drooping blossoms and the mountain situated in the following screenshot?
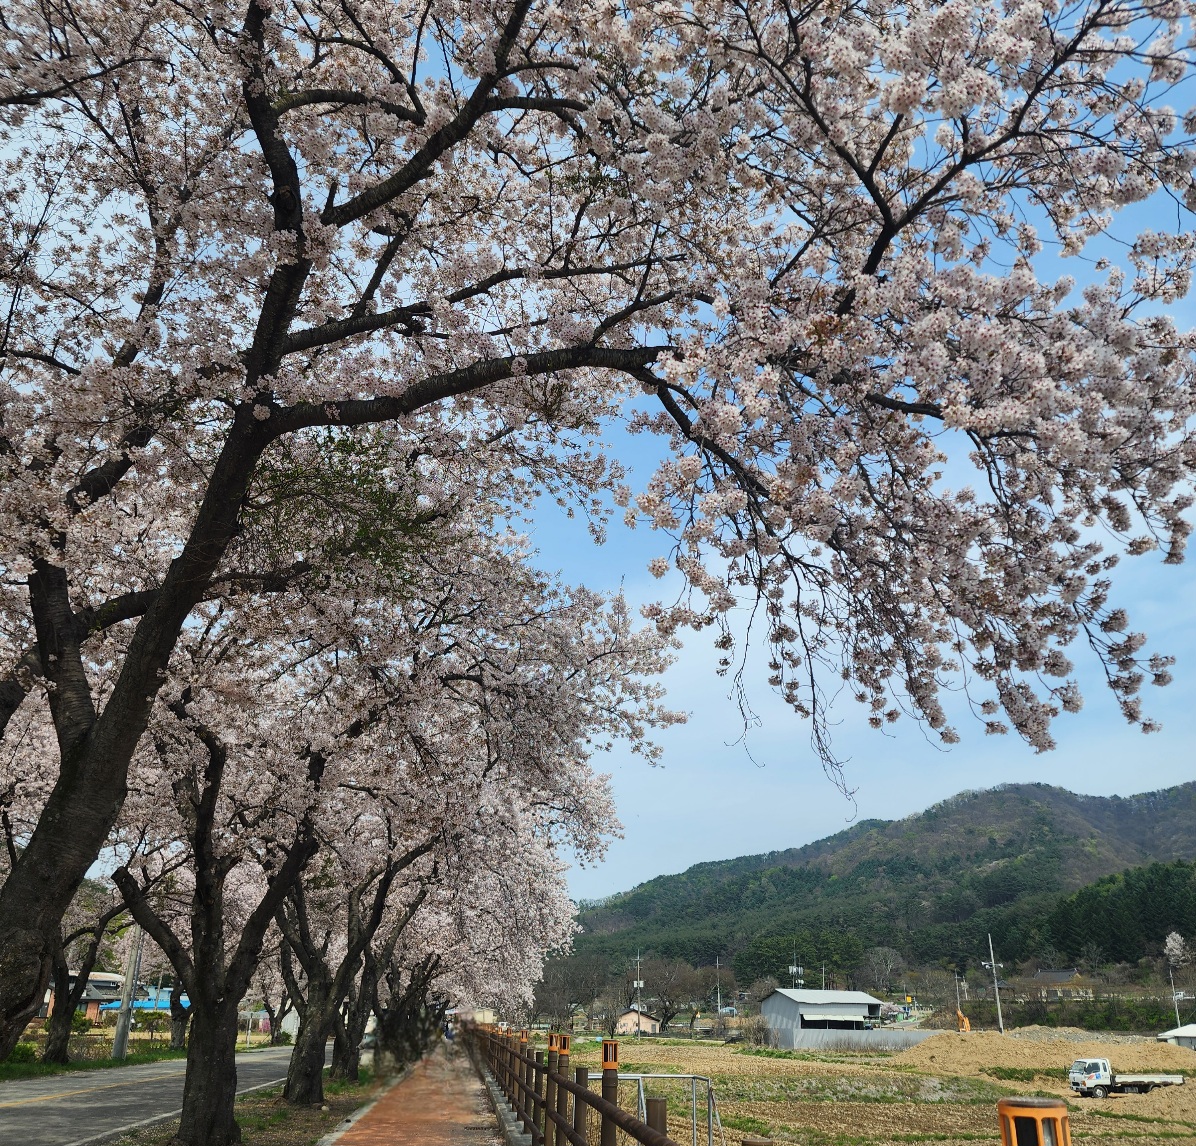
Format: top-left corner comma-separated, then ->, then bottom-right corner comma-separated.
532,421 -> 1196,898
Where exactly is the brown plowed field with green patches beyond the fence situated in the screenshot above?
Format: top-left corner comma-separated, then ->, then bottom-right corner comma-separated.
562,1029 -> 1196,1146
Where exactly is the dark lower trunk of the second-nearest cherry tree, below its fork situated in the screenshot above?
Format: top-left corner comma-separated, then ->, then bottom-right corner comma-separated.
176,1000 -> 240,1146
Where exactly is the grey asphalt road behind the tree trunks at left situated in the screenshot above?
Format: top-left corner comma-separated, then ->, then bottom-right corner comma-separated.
0,1047 -> 313,1146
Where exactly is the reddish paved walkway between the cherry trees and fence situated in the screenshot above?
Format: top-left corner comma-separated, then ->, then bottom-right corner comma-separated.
336,1047 -> 501,1146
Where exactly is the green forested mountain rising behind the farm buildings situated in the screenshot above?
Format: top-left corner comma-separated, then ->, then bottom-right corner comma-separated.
578,782 -> 1196,982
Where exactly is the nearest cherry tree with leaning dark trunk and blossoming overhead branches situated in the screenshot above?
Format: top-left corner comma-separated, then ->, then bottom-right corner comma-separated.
0,0 -> 1194,1054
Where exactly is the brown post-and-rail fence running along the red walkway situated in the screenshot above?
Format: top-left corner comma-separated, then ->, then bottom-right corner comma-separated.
471,1025 -> 688,1146
